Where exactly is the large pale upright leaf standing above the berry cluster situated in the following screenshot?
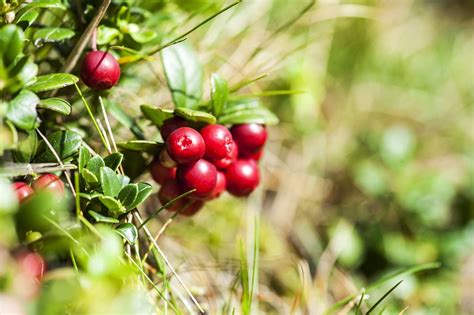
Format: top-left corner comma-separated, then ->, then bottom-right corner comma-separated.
161,43 -> 203,108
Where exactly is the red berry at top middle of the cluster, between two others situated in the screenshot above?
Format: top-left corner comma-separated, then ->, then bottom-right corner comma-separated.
201,124 -> 234,160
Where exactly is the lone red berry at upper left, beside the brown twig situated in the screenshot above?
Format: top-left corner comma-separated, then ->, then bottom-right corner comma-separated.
81,51 -> 120,90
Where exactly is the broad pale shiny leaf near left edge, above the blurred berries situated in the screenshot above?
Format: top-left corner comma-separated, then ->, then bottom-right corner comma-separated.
6,90 -> 39,130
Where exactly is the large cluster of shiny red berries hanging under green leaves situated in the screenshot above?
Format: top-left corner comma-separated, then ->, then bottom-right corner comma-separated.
150,117 -> 267,215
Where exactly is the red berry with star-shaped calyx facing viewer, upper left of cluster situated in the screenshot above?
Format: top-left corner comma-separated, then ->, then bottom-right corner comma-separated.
166,127 -> 206,164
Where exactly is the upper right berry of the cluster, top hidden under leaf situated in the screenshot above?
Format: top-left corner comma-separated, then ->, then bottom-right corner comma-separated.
230,124 -> 267,154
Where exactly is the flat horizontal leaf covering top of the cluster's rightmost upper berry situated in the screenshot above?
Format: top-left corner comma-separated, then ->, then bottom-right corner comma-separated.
219,107 -> 278,125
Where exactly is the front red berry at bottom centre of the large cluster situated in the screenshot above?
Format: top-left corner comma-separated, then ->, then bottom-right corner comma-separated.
176,159 -> 217,199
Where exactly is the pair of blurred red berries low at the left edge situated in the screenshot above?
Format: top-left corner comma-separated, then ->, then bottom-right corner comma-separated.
12,174 -> 64,203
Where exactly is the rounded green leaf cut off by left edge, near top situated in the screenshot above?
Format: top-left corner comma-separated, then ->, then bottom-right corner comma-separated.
0,24 -> 25,66
